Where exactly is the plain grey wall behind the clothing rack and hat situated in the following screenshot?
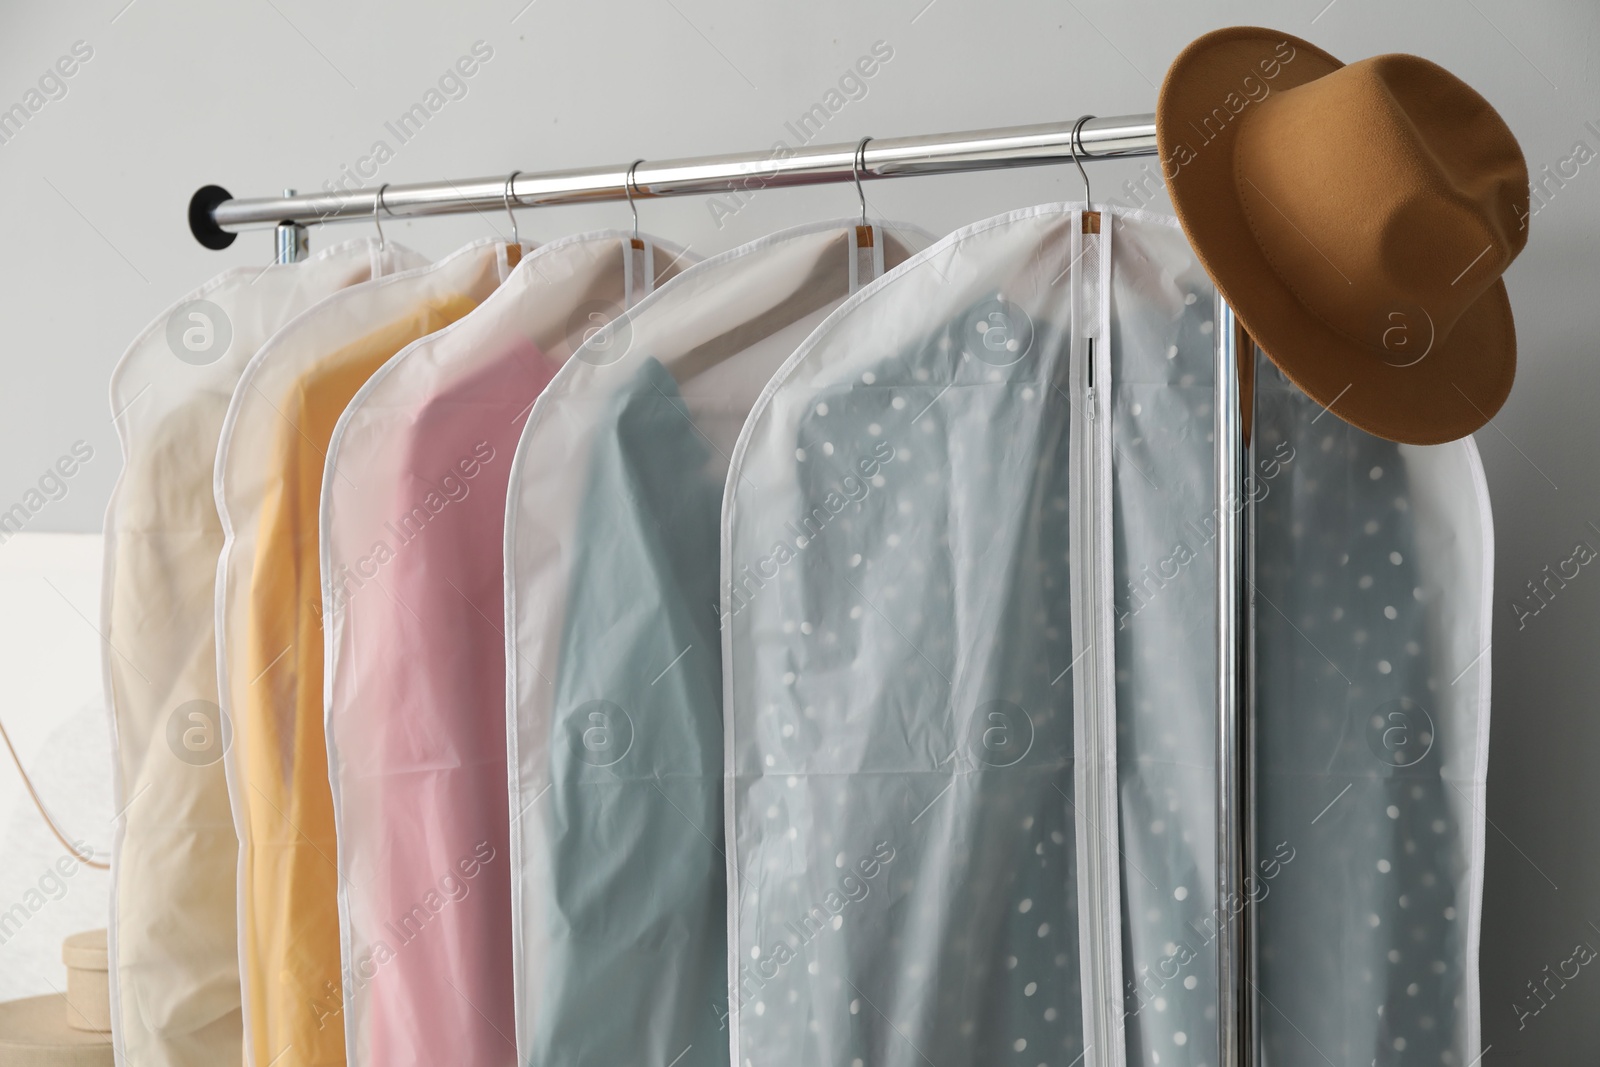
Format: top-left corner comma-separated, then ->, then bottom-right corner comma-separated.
0,0 -> 1600,1064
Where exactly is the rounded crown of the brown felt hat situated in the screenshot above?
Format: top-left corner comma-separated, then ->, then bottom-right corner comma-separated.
1234,54 -> 1528,362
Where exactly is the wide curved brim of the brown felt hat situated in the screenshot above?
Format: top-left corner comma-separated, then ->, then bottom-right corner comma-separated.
1155,26 -> 1517,445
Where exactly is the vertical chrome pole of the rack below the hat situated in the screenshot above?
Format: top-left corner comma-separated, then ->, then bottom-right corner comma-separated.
1214,293 -> 1258,1067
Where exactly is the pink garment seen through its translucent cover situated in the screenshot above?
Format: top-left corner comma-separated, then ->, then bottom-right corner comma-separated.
346,342 -> 558,1065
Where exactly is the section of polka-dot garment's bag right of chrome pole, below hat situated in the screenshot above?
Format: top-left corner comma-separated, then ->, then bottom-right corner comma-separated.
1256,360 -> 1494,1067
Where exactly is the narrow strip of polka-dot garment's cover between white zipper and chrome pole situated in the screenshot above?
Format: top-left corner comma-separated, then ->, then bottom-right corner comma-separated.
1110,216 -> 1218,1064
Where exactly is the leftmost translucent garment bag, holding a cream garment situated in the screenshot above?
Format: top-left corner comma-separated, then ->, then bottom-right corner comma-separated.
101,240 -> 426,1067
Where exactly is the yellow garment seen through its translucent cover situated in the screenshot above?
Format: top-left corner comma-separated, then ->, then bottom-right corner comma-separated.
230,296 -> 475,1067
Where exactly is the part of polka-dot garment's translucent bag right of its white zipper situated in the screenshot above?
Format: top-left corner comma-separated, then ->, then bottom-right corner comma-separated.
1112,343 -> 1493,1067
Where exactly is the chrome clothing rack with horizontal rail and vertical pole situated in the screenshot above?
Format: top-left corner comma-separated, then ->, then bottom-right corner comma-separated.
189,115 -> 1259,1067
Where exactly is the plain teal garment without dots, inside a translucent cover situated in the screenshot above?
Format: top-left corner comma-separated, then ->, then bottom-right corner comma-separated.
526,358 -> 728,1067
